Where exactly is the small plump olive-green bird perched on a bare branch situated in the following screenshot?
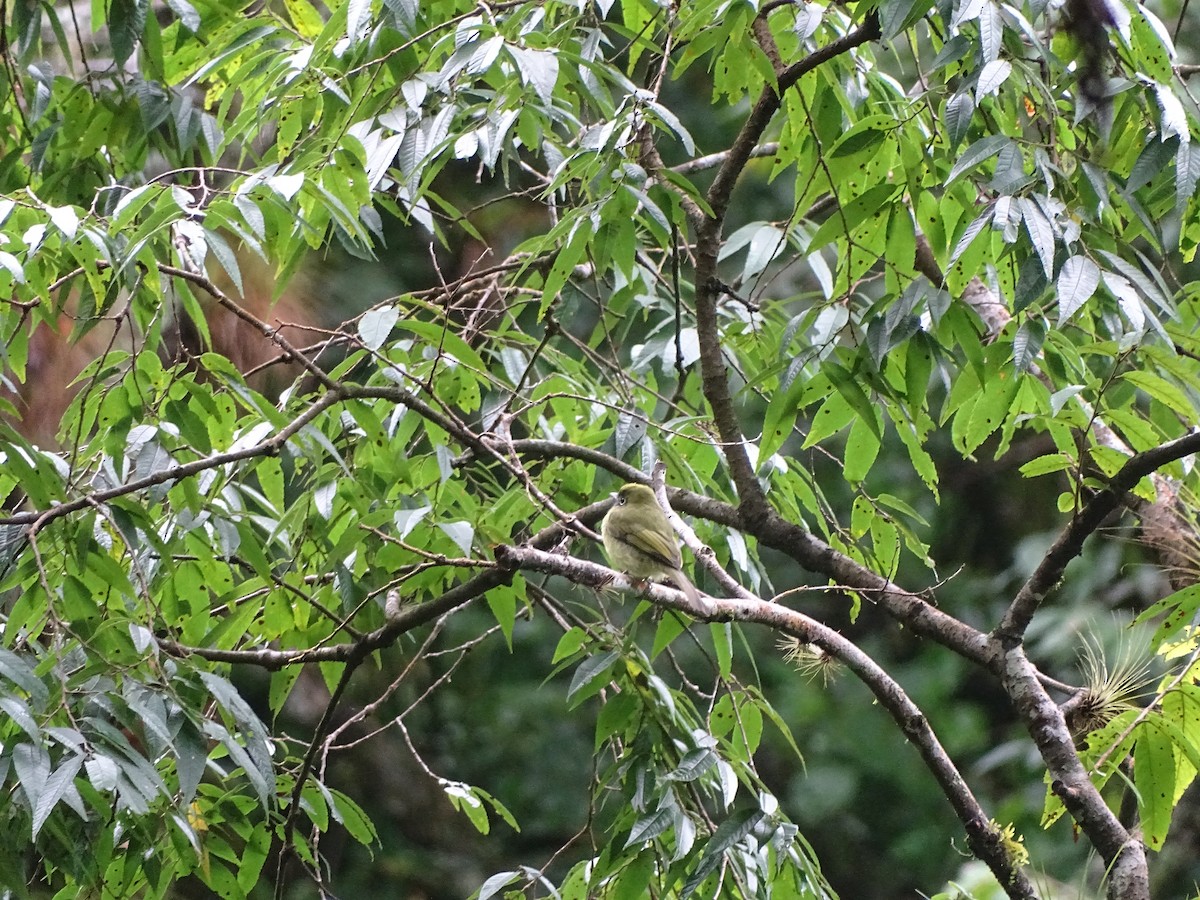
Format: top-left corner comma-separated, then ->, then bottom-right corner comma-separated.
600,485 -> 700,604
